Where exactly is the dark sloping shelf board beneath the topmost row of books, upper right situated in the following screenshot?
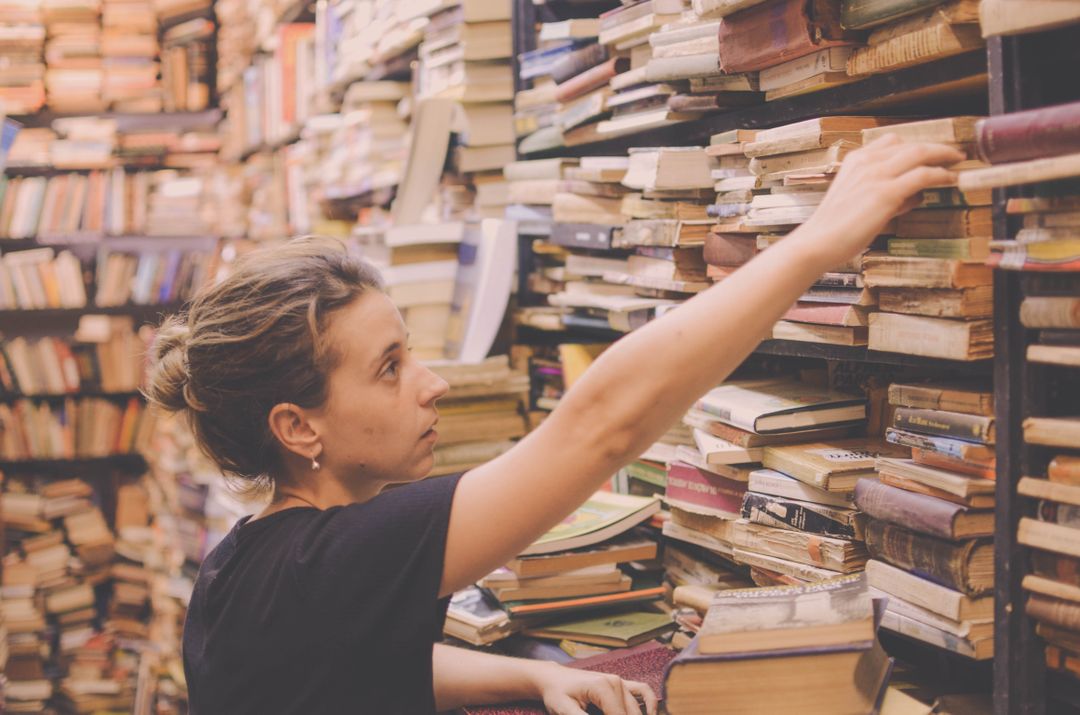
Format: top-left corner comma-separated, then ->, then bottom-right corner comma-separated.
516,51 -> 987,159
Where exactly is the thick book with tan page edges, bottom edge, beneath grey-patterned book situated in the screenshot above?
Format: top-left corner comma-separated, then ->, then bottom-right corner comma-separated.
664,635 -> 891,715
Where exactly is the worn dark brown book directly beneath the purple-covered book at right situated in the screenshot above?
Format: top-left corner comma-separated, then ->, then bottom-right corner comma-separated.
866,518 -> 990,596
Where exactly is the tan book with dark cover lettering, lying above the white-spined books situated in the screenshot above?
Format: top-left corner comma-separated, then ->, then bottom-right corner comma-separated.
761,437 -> 906,491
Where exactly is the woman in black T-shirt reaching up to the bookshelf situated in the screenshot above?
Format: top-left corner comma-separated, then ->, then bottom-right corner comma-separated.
148,137 -> 962,715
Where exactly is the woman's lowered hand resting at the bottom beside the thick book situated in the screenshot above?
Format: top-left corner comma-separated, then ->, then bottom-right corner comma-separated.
536,663 -> 657,715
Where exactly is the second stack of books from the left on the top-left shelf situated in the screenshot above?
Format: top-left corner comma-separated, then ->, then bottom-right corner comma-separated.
42,0 -> 108,113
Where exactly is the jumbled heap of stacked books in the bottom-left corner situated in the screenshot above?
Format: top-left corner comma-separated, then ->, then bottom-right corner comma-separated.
2,480 -> 142,712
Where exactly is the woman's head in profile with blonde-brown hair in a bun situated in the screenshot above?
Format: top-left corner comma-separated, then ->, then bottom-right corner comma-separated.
147,238 -> 446,501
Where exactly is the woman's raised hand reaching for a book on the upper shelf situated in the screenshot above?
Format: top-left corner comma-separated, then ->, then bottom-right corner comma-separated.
799,134 -> 964,264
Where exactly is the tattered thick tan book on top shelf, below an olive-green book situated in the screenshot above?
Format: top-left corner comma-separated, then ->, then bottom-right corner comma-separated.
848,8 -> 984,77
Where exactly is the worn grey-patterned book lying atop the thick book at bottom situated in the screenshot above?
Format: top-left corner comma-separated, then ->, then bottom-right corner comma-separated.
698,575 -> 874,657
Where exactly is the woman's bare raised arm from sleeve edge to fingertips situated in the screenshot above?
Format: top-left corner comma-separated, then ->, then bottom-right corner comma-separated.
442,136 -> 963,594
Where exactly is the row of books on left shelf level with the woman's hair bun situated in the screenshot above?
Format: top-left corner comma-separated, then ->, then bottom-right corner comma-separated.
0,316 -> 146,396
